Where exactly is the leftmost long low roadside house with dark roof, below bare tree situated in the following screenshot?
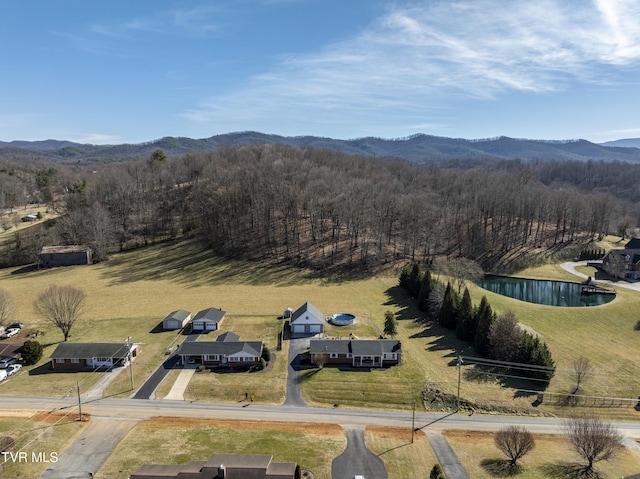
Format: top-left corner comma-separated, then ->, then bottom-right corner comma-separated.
51,342 -> 140,371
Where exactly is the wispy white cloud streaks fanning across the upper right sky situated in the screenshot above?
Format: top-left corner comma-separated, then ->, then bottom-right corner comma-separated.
183,0 -> 640,137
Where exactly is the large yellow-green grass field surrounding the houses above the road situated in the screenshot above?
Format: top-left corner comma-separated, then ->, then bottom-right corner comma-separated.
0,243 -> 640,417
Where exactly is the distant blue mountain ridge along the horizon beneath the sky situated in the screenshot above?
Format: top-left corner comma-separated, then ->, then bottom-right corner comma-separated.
0,131 -> 640,163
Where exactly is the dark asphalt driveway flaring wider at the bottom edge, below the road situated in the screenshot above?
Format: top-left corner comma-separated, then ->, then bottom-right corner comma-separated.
331,426 -> 388,479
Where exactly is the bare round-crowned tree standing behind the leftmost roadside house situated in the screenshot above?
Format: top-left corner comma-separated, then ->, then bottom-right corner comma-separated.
33,285 -> 84,341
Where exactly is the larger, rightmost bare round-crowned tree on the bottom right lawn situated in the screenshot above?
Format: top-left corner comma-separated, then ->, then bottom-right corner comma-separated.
564,418 -> 623,477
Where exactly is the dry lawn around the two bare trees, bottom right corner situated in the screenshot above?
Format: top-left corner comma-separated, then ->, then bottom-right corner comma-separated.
444,431 -> 640,479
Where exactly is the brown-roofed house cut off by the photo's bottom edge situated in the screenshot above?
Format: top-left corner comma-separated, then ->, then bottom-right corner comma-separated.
129,454 -> 298,479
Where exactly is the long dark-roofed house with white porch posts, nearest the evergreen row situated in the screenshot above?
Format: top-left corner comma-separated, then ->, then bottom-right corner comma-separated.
309,339 -> 402,368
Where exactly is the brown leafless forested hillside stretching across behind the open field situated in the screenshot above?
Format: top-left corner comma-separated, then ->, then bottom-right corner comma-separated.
0,145 -> 640,272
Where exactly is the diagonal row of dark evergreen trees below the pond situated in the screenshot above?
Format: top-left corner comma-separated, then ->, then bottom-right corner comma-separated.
399,264 -> 555,387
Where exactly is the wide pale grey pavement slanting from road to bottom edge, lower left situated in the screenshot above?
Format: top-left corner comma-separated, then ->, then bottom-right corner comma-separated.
40,418 -> 138,479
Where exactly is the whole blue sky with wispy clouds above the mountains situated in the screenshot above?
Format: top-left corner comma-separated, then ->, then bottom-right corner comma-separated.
0,0 -> 640,144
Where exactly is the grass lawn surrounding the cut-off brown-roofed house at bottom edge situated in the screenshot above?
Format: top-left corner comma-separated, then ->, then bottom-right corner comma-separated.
95,418 -> 344,479
